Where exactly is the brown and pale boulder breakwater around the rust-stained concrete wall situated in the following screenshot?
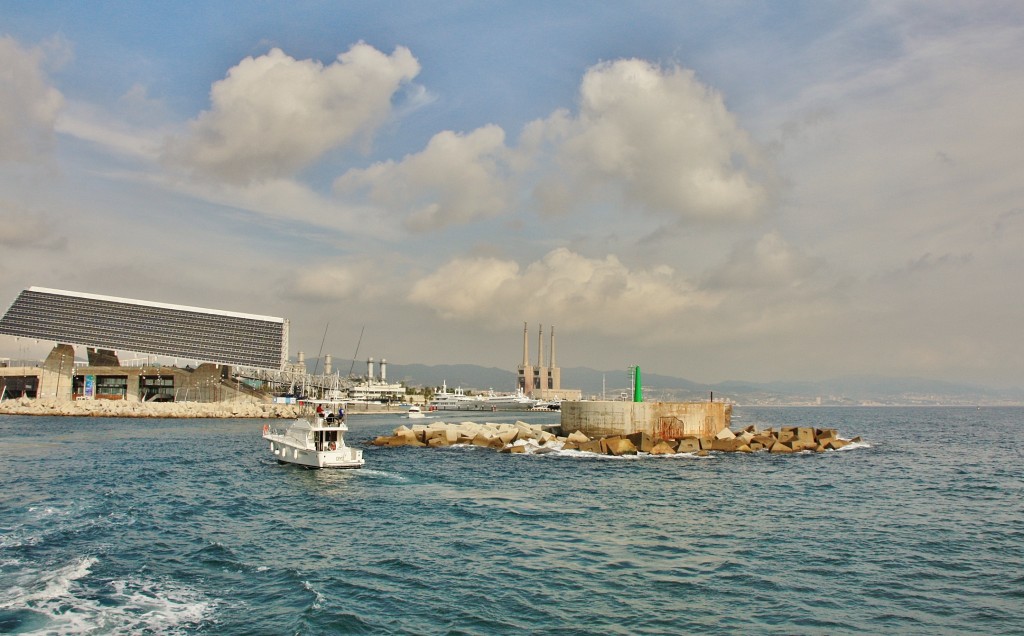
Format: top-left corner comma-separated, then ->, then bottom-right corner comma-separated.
373,422 -> 860,456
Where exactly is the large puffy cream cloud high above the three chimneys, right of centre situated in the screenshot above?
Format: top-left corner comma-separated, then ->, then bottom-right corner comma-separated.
523,59 -> 772,219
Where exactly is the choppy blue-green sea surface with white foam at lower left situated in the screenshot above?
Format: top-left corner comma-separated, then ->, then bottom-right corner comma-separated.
0,408 -> 1024,635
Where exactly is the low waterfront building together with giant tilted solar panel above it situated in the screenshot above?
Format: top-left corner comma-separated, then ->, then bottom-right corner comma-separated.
0,287 -> 288,401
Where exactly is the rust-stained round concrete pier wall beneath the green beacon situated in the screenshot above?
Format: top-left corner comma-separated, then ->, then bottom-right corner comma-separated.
561,401 -> 732,439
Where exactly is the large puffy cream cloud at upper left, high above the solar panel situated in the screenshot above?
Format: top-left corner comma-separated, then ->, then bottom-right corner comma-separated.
166,43 -> 420,183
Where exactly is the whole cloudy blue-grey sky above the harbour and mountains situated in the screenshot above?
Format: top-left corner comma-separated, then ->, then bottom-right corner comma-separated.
0,0 -> 1024,389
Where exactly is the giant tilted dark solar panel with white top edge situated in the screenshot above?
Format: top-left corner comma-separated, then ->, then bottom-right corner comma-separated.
0,287 -> 288,369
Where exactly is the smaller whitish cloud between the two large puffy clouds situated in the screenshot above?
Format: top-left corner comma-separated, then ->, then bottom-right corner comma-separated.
335,126 -> 511,231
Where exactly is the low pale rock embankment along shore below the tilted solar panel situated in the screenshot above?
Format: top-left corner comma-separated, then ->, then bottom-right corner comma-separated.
0,397 -> 300,418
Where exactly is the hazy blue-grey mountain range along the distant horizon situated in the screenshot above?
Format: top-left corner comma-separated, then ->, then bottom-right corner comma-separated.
335,361 -> 1024,406
